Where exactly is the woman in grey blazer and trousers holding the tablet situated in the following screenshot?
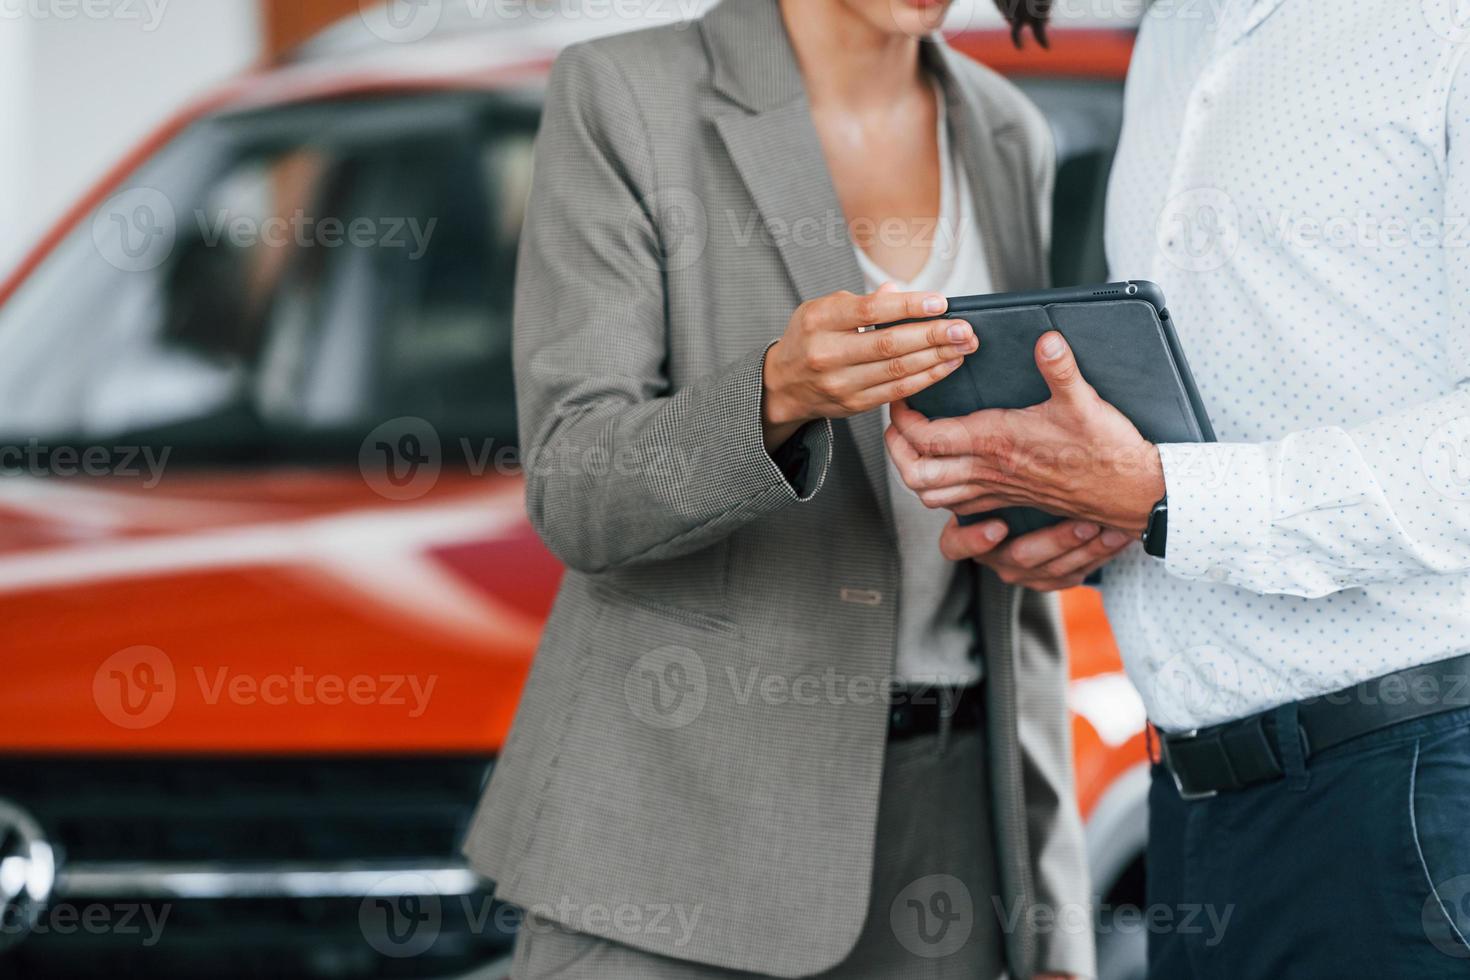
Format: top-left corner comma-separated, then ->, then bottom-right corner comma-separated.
466,0 -> 1094,980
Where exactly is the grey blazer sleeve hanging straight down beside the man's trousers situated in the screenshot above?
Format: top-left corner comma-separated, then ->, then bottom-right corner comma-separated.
1016,589 -> 1097,977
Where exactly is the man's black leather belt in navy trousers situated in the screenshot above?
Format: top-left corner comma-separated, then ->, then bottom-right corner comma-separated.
1160,654 -> 1470,799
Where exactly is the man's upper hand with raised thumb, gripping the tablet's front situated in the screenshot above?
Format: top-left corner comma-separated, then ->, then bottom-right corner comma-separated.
886,331 -> 1164,536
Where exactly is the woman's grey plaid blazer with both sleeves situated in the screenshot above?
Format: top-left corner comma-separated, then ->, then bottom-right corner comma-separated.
465,0 -> 1094,977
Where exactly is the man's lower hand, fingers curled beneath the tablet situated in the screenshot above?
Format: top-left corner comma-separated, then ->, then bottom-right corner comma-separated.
939,517 -> 1132,592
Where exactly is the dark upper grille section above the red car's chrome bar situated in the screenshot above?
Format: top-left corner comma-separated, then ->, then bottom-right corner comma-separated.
0,757 -> 488,865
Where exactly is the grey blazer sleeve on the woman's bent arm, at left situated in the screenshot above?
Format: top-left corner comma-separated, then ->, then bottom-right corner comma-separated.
515,44 -> 832,572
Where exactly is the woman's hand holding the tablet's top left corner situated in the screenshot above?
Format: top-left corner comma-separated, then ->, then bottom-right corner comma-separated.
761,284 -> 979,450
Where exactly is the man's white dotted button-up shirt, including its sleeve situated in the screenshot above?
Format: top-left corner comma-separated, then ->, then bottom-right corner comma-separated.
1104,0 -> 1470,730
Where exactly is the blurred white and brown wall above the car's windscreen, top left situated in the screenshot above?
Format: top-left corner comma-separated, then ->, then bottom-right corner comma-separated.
0,0 -> 359,276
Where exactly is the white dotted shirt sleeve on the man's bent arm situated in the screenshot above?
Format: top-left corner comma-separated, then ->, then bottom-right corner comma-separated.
1160,59 -> 1470,598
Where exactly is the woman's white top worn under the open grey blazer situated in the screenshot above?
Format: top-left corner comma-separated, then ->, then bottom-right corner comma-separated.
856,87 -> 991,685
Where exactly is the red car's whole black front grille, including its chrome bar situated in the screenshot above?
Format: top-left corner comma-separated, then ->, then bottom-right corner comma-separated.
0,757 -> 515,977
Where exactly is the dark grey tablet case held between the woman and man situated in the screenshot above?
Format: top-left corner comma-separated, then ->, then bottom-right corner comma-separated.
908,281 -> 1214,535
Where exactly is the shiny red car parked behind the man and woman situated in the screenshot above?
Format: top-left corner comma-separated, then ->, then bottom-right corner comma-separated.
0,9 -> 1145,979
